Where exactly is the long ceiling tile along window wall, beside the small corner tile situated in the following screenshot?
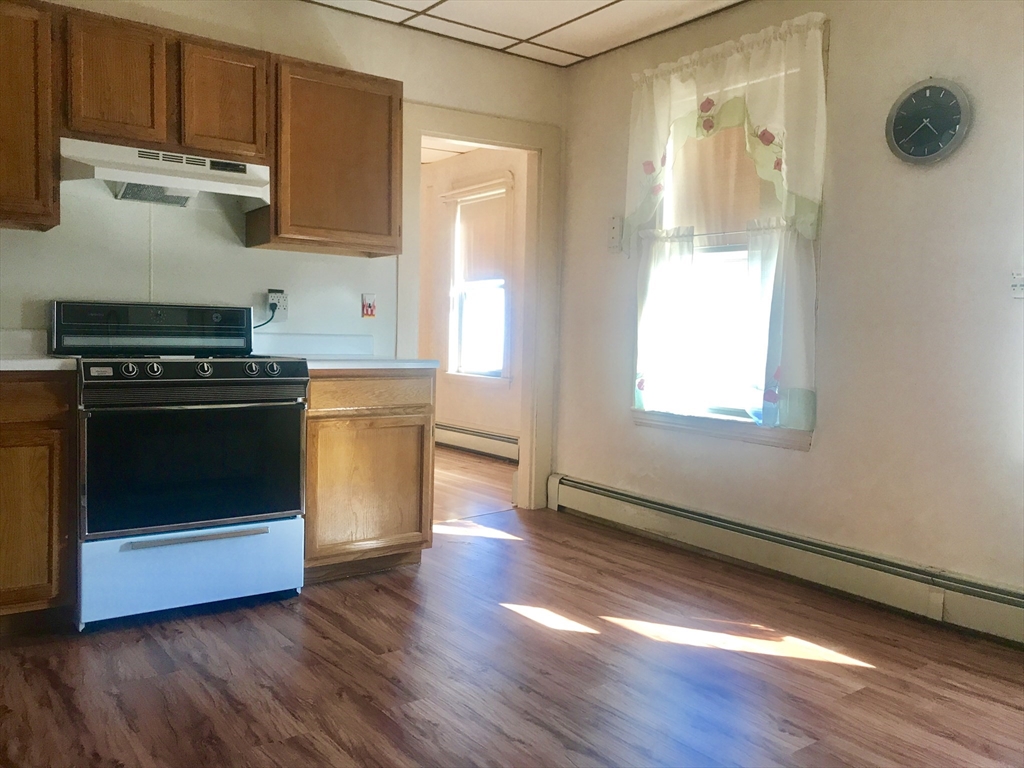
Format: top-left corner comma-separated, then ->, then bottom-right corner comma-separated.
535,0 -> 741,56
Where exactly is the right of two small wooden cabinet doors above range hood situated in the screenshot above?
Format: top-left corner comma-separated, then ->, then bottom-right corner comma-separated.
181,42 -> 267,156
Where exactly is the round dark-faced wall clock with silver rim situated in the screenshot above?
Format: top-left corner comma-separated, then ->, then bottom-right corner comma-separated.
886,79 -> 971,163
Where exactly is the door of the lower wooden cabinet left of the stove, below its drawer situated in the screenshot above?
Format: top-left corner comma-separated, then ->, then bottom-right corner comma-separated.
0,428 -> 63,610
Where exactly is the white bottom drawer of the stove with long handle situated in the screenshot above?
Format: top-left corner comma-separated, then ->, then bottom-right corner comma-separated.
79,517 -> 304,627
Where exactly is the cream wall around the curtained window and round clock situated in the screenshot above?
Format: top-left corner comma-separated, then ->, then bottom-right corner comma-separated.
555,0 -> 1024,590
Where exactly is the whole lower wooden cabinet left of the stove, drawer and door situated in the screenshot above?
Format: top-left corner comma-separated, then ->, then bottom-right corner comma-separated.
0,374 -> 74,615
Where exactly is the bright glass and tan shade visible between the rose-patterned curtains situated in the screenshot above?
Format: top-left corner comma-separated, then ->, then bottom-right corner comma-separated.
635,127 -> 779,421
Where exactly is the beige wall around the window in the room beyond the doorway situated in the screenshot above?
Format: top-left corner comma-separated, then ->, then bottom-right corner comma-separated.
419,150 -> 527,437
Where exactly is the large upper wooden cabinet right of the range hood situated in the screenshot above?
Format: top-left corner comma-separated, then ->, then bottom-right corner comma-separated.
247,59 -> 402,255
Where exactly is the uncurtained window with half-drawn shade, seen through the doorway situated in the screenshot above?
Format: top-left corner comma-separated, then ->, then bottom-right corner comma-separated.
447,187 -> 510,377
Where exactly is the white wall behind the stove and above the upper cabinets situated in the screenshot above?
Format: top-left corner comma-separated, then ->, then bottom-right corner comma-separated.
0,0 -> 567,356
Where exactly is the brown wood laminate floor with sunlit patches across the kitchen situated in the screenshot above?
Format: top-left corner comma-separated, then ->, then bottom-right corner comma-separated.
0,456 -> 1024,768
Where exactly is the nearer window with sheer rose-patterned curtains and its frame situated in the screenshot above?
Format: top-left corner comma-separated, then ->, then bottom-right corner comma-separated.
625,13 -> 825,430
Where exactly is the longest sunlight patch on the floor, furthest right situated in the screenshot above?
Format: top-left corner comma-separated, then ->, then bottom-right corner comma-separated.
601,616 -> 874,669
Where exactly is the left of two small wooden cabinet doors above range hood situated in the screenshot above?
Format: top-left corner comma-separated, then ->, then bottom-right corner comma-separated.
68,15 -> 167,141
